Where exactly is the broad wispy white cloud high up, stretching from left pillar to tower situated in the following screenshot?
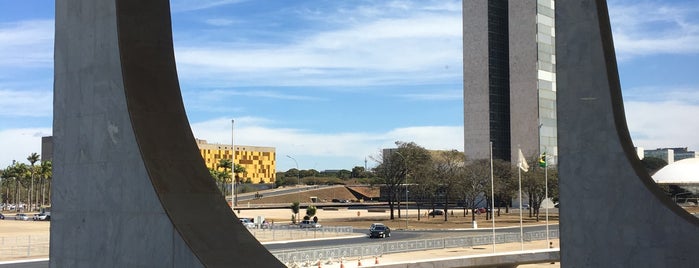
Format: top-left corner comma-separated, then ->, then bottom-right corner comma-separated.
175,5 -> 462,86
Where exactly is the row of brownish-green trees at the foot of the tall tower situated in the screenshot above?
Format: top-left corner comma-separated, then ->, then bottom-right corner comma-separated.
374,141 -> 558,221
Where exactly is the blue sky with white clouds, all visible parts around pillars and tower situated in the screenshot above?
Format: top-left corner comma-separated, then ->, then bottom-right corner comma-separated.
0,0 -> 699,171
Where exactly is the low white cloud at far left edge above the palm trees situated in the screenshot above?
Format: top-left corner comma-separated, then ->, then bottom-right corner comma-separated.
0,128 -> 52,169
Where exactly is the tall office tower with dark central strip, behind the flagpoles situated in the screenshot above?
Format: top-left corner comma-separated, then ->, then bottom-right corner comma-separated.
463,0 -> 558,164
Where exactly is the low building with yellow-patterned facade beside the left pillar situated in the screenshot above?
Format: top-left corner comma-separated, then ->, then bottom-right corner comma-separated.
196,139 -> 277,183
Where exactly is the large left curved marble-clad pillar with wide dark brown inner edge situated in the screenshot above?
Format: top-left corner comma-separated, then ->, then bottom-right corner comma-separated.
50,0 -> 283,267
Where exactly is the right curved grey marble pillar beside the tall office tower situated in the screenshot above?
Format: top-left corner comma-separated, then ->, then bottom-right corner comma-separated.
556,0 -> 699,267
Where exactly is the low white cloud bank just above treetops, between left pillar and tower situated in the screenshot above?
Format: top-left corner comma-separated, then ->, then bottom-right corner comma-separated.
192,117 -> 464,168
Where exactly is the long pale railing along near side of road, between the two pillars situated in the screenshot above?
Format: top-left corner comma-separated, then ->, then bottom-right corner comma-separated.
272,230 -> 559,264
